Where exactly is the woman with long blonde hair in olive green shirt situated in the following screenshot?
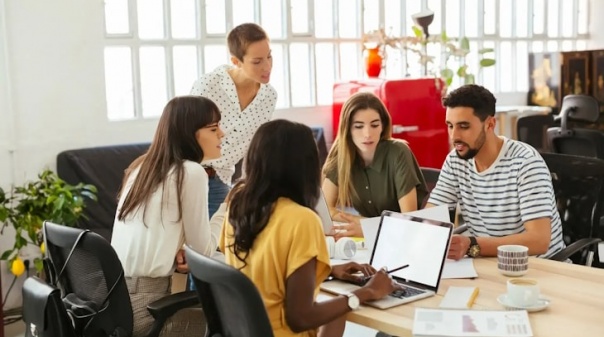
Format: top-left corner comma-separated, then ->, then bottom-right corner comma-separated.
322,93 -> 428,238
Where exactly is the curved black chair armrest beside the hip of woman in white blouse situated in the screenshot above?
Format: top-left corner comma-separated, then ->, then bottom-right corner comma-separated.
147,291 -> 203,337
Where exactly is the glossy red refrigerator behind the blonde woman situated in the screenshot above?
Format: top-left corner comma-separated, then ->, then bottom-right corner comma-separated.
332,78 -> 450,169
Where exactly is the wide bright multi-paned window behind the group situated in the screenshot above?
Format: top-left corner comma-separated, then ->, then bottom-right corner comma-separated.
104,0 -> 589,120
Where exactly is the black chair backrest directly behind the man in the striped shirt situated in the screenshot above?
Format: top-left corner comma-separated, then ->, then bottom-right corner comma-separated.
541,153 -> 604,252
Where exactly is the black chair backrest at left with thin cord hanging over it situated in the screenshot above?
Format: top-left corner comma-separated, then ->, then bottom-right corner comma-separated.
43,221 -> 133,336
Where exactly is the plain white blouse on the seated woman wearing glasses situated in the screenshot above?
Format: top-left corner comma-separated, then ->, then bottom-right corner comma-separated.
111,161 -> 222,277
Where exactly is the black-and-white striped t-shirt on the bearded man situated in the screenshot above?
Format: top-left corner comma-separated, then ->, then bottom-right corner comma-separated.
428,138 -> 565,257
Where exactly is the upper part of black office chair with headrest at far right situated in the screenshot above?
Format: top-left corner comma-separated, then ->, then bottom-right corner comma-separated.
547,95 -> 604,159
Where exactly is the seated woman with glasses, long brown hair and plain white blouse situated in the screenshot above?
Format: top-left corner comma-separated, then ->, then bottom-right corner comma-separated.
111,96 -> 224,337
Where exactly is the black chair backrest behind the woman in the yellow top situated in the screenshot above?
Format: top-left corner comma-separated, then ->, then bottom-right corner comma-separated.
186,247 -> 273,337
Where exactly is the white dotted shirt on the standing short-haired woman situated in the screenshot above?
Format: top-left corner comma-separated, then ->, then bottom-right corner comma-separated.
191,65 -> 277,185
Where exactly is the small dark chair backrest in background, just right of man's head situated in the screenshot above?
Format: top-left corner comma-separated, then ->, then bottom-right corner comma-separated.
516,114 -> 554,152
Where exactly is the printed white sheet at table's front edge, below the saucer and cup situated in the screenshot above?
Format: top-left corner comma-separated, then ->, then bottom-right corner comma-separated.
413,308 -> 533,337
